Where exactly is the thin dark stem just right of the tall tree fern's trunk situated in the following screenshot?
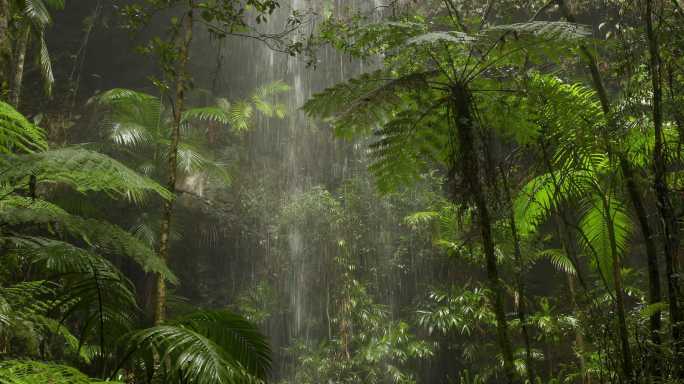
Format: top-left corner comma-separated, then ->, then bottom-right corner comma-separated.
501,169 -> 535,383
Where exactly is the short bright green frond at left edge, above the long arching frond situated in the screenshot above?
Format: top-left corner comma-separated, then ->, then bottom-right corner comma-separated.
0,101 -> 47,154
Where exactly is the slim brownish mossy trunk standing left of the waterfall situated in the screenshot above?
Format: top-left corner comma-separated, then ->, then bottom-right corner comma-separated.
154,4 -> 194,324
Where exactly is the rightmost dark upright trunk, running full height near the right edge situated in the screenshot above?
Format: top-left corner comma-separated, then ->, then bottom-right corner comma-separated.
644,0 -> 684,377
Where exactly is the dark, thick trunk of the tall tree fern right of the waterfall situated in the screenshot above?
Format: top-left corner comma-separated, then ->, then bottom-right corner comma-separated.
452,87 -> 518,383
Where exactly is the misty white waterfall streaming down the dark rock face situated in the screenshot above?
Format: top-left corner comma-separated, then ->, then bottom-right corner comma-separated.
188,0 -> 392,378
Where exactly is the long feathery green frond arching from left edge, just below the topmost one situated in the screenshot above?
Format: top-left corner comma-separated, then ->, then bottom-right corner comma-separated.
0,147 -> 173,202
